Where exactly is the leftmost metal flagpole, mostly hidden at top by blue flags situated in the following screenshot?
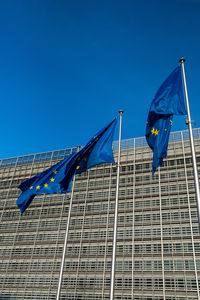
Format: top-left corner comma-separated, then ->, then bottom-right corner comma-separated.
56,146 -> 80,300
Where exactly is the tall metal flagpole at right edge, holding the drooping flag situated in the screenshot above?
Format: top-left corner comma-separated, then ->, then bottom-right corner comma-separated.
179,57 -> 200,228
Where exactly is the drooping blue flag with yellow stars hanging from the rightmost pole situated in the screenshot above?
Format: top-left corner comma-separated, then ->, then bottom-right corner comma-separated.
146,66 -> 186,174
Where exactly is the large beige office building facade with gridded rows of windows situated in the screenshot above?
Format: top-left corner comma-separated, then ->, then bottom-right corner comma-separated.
0,129 -> 200,300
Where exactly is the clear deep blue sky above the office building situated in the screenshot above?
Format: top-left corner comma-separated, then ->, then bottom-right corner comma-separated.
0,0 -> 200,158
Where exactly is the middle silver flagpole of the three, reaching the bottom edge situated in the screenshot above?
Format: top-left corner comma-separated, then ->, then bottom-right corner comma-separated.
110,110 -> 123,300
